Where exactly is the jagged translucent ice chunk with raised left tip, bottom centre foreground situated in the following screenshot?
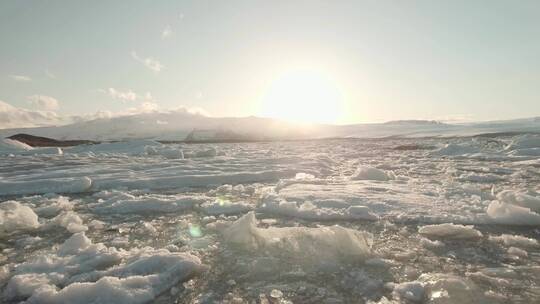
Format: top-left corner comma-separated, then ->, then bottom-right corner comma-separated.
223,212 -> 372,263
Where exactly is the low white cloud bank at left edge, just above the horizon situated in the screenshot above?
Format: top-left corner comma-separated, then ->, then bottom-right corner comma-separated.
0,100 -> 64,129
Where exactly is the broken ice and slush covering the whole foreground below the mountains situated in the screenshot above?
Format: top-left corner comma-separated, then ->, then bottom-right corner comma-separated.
0,135 -> 540,304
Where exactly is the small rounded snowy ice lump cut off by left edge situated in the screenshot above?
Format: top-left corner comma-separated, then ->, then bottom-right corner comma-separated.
0,201 -> 39,236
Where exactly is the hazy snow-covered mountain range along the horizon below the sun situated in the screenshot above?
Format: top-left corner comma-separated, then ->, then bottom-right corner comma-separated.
0,111 -> 540,141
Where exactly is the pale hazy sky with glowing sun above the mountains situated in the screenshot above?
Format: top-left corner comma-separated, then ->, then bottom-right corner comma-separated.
0,0 -> 540,127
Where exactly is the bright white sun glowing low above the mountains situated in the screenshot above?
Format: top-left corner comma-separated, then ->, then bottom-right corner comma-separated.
260,70 -> 342,123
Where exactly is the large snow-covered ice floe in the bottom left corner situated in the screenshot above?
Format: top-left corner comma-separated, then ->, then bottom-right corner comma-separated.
3,232 -> 205,303
